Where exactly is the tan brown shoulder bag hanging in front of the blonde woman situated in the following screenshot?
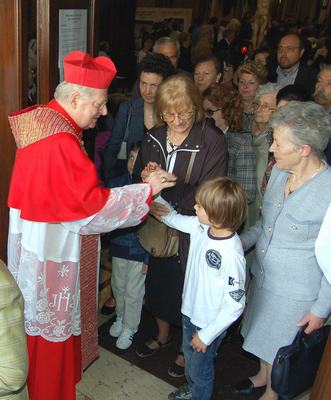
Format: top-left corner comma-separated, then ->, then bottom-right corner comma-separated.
137,153 -> 196,258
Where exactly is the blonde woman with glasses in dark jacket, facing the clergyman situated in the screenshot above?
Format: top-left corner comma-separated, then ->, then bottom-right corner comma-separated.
134,75 -> 228,377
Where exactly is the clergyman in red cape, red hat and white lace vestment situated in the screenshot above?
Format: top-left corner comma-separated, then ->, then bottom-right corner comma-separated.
8,51 -> 174,400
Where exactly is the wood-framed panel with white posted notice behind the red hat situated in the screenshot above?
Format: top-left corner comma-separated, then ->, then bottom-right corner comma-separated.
37,0 -> 99,104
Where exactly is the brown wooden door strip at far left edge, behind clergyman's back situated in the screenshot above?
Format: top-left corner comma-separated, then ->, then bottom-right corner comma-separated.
0,0 -> 28,261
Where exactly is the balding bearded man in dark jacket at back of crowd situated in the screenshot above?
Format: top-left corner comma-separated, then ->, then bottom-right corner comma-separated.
273,33 -> 317,95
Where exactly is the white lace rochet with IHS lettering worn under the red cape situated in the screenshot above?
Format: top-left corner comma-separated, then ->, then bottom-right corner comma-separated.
8,184 -> 150,342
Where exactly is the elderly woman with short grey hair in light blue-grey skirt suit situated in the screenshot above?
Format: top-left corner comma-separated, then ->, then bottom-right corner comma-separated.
235,101 -> 331,400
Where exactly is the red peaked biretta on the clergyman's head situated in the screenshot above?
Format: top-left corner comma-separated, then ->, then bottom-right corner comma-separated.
63,50 -> 117,89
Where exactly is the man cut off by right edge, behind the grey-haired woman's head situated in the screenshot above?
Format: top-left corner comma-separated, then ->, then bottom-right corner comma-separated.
314,65 -> 331,164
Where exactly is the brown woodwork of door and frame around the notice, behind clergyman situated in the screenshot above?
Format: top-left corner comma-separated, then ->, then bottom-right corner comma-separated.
0,0 -> 99,261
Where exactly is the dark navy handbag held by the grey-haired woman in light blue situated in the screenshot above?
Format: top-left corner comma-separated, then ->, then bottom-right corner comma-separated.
271,325 -> 330,400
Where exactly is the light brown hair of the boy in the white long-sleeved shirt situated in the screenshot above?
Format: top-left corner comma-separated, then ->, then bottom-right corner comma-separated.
196,177 -> 247,232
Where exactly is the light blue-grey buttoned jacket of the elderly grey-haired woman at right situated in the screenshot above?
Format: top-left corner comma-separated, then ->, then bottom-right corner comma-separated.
241,166 -> 331,317
